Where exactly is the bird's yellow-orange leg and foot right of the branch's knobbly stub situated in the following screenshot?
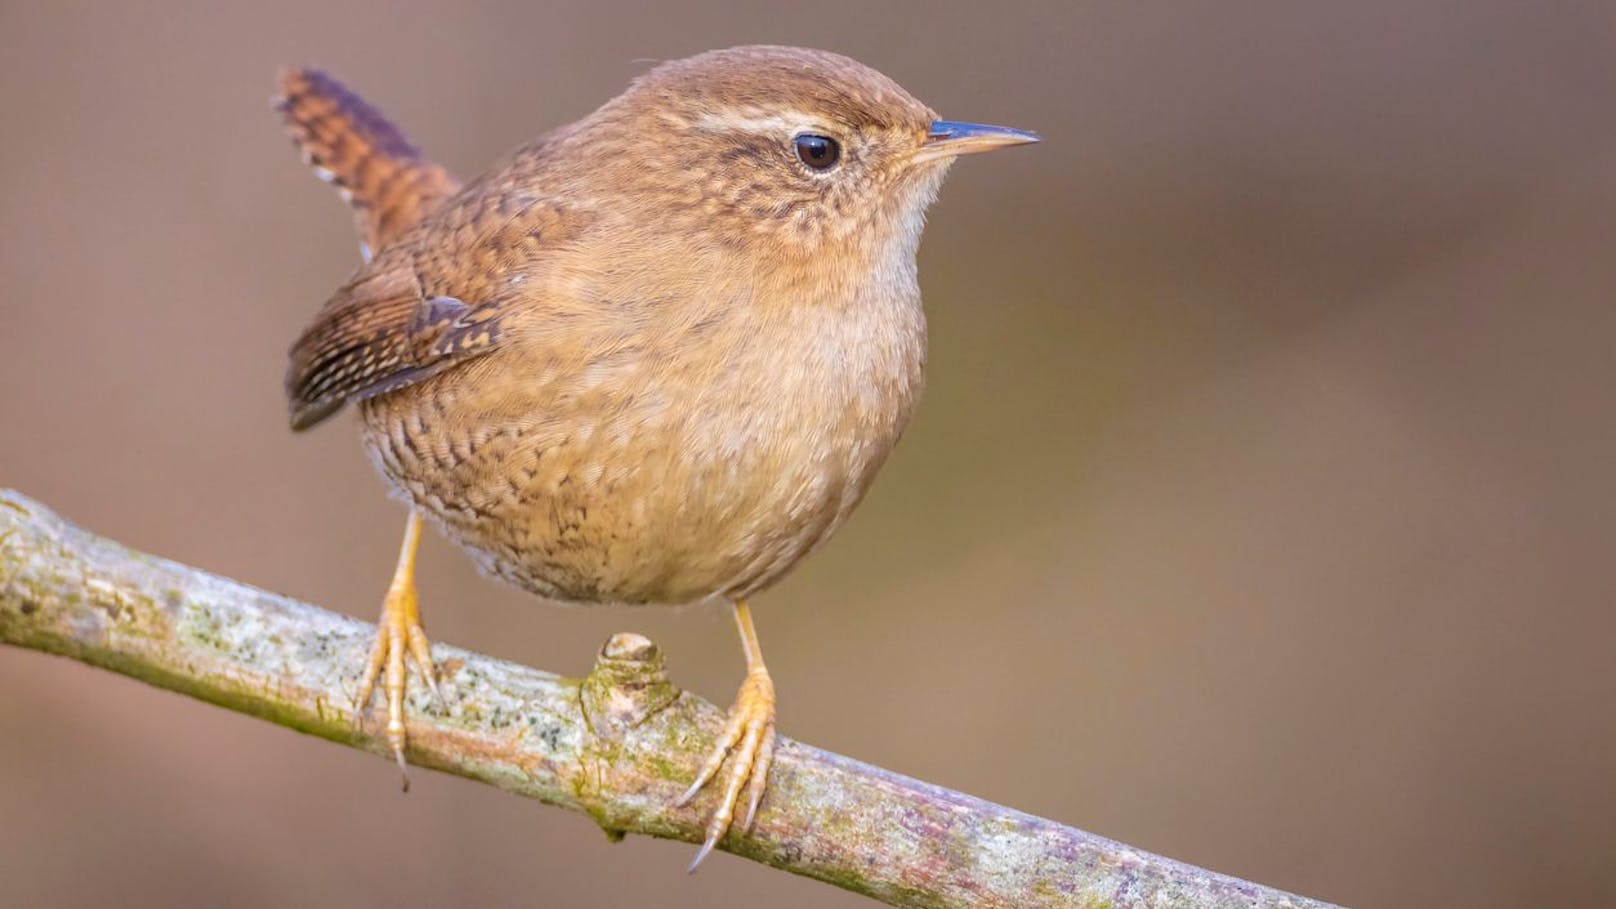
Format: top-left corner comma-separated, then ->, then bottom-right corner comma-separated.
677,600 -> 774,870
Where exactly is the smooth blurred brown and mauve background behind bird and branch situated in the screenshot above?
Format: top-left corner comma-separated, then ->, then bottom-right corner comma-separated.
0,0 -> 1616,909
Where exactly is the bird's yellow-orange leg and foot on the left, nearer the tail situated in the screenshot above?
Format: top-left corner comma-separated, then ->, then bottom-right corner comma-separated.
354,511 -> 438,793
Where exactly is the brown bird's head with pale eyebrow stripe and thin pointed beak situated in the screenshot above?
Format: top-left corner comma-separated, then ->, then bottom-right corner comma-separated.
587,45 -> 1037,263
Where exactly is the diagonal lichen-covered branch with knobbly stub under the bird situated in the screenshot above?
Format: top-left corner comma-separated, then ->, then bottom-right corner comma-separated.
0,490 -> 1325,909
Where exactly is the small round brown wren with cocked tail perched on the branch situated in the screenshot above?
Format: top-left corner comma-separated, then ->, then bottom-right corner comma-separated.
276,47 -> 1037,867
